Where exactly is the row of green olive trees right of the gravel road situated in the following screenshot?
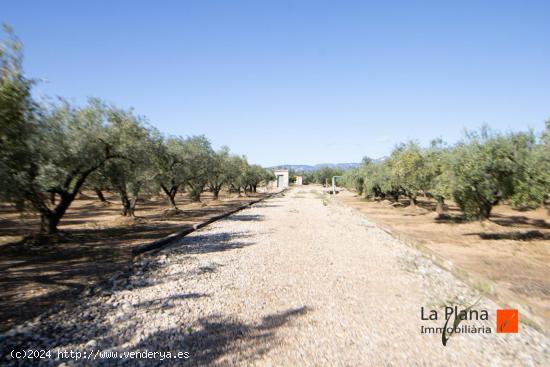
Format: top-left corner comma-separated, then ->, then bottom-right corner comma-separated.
344,126 -> 550,219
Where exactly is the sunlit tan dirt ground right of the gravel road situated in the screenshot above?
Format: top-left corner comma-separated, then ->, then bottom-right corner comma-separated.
336,190 -> 550,331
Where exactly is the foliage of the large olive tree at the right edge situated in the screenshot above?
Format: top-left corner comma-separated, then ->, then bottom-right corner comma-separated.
451,128 -> 548,219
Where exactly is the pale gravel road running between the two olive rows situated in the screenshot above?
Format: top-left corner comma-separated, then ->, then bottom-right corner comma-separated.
0,186 -> 550,366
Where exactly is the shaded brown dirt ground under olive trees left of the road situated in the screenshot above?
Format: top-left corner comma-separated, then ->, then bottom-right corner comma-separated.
0,192 -> 265,331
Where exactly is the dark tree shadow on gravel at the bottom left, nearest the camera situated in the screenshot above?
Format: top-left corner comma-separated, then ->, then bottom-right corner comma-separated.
0,293 -> 311,366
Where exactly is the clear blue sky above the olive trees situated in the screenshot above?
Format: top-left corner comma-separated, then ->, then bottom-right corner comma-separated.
4,0 -> 550,166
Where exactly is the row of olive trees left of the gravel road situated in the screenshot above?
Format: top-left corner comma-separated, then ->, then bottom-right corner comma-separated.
0,25 -> 273,234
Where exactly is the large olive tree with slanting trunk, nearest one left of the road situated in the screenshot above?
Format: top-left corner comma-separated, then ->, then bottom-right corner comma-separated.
1,101 -> 126,234
